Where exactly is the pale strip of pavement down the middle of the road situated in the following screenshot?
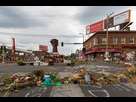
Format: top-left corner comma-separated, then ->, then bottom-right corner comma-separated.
49,72 -> 85,97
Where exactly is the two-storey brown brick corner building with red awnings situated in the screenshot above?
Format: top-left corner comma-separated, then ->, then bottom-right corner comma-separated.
83,31 -> 136,58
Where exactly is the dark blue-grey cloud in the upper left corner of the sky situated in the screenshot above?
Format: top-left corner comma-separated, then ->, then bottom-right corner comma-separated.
0,6 -> 48,28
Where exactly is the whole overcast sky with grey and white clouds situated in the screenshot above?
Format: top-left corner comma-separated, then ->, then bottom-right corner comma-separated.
0,6 -> 136,55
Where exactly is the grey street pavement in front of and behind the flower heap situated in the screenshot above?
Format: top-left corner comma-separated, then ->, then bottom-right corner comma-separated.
0,62 -> 136,97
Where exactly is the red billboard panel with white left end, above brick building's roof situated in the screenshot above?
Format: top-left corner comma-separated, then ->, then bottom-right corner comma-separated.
86,21 -> 103,34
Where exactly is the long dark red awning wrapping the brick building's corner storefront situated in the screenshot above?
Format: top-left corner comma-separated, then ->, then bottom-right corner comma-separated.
85,48 -> 123,54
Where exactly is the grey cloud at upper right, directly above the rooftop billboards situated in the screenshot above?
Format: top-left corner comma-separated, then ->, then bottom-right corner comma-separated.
73,6 -> 130,26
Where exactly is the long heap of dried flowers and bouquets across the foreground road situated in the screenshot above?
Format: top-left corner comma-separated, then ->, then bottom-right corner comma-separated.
0,65 -> 136,96
